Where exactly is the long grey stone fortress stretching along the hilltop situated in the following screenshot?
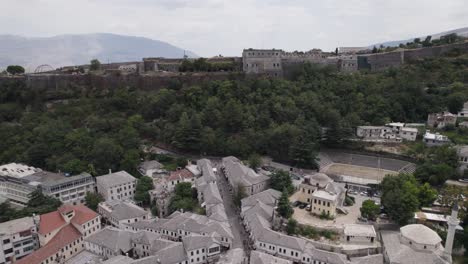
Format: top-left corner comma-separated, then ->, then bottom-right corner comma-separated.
47,41 -> 468,77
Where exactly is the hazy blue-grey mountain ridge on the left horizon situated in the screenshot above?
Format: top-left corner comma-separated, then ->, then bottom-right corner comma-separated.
0,33 -> 198,72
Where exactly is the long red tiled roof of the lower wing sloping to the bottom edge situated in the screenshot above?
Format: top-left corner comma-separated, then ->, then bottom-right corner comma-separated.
15,224 -> 81,264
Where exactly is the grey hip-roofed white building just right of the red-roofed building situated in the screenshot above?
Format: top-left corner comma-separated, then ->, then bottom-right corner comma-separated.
98,200 -> 151,228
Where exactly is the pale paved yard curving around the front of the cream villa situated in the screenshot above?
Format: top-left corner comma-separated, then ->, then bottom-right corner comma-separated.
290,193 -> 380,228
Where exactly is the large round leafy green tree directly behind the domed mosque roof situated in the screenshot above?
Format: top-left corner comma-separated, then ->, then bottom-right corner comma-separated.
380,173 -> 420,225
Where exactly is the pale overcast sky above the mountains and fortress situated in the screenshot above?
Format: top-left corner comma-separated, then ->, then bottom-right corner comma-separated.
0,0 -> 468,56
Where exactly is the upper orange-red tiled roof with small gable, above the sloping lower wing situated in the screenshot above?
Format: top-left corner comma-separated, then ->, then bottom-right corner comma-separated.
38,205 -> 98,235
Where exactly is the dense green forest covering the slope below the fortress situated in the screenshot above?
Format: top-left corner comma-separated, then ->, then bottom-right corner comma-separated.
0,53 -> 468,175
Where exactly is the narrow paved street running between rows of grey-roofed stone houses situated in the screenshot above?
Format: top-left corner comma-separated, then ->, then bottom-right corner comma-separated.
213,164 -> 248,250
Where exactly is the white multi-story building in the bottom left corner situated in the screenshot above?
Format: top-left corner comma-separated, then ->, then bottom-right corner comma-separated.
0,217 -> 39,264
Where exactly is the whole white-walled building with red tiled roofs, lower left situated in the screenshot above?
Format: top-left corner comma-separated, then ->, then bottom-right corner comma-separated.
16,205 -> 101,264
